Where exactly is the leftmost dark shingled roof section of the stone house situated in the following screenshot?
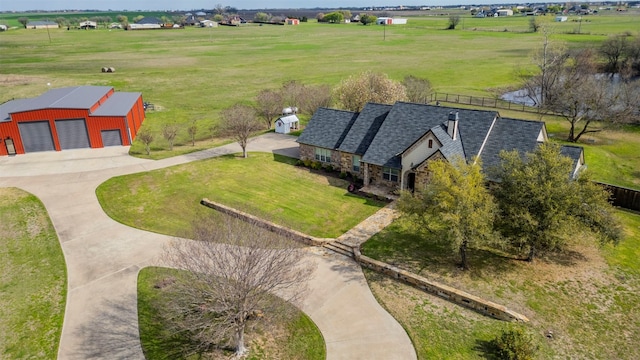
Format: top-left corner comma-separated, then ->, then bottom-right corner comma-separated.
296,108 -> 358,149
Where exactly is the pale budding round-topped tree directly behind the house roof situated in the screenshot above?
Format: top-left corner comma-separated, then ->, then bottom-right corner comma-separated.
334,71 -> 407,111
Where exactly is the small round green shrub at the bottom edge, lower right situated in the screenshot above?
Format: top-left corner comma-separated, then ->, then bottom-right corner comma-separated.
491,328 -> 539,360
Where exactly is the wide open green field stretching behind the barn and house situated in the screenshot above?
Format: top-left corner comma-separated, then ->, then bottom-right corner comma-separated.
0,12 -> 640,153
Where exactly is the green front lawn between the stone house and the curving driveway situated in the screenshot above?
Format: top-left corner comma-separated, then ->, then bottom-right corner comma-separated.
97,153 -> 383,237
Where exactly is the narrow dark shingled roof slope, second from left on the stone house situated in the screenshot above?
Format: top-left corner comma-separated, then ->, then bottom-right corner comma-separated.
338,103 -> 391,155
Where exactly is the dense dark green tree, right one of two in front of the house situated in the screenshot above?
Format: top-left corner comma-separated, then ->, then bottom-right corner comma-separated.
495,143 -> 622,261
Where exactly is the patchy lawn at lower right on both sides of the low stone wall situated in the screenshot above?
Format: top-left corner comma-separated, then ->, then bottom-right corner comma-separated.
363,211 -> 640,359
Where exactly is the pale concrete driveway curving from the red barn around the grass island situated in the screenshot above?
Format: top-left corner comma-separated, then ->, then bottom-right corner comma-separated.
0,134 -> 416,359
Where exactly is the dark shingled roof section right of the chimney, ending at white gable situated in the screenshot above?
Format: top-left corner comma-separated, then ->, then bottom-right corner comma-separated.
478,118 -> 546,169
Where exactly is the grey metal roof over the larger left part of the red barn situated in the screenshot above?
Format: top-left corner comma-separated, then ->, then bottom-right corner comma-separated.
11,86 -> 113,113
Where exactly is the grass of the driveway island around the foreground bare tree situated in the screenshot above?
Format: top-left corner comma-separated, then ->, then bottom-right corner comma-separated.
138,268 -> 326,360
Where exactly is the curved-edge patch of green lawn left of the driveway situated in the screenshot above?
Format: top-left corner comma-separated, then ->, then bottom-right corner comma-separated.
0,188 -> 67,359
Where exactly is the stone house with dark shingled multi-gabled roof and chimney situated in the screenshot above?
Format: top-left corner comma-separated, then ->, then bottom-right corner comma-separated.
297,102 -> 584,190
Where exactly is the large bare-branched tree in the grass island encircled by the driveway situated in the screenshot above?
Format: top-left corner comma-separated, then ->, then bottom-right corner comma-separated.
164,216 -> 314,356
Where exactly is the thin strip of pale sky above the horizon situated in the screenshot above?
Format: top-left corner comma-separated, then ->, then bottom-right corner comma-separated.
0,0 -> 513,11
